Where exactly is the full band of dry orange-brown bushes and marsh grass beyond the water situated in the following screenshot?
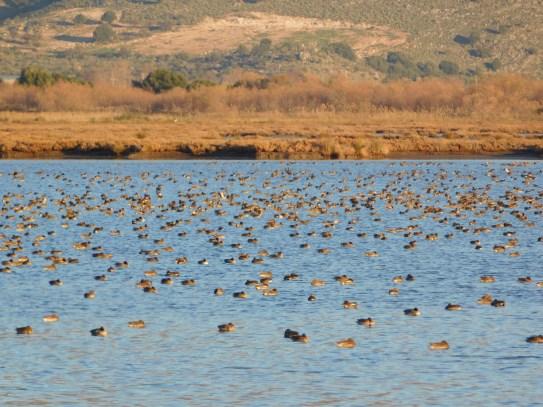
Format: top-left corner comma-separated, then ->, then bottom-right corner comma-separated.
0,76 -> 543,158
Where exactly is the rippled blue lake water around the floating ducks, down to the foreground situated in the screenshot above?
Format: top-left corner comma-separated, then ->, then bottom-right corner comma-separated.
0,161 -> 543,406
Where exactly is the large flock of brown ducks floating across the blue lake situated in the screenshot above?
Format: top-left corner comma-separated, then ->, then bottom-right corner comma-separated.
0,162 -> 543,350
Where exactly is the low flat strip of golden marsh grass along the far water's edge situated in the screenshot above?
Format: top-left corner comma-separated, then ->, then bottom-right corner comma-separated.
0,112 -> 543,160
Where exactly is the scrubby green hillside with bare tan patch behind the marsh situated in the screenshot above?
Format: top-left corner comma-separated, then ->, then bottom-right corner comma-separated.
0,0 -> 543,82
